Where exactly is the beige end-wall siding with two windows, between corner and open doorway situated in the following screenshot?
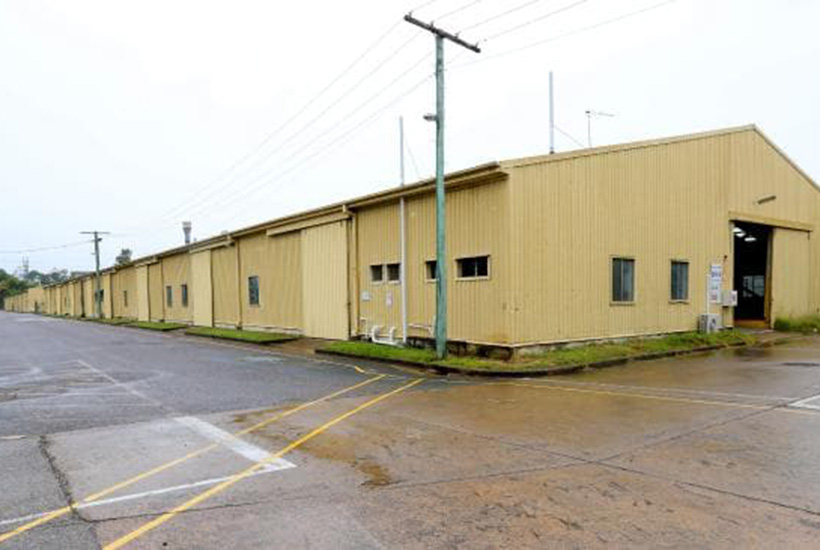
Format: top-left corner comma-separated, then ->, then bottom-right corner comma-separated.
510,138 -> 732,343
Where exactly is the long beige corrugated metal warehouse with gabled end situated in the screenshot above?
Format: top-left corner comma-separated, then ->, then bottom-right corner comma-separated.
8,126 -> 820,347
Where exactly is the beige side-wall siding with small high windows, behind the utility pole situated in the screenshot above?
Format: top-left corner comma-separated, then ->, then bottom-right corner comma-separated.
355,183 -> 510,343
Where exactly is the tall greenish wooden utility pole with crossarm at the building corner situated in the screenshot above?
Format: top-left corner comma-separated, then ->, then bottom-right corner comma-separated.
404,13 -> 481,359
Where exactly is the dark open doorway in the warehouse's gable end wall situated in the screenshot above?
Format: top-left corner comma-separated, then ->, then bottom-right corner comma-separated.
733,222 -> 772,321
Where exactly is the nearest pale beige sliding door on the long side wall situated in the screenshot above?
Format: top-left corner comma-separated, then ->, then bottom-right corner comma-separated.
301,222 -> 350,339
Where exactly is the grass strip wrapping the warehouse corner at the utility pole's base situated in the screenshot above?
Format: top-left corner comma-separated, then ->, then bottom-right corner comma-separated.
323,330 -> 756,373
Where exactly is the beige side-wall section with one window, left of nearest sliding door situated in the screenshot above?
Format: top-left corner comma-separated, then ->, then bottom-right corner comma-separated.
239,231 -> 303,331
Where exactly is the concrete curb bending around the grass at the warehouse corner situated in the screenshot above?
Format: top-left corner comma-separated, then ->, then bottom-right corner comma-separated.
316,335 -> 800,378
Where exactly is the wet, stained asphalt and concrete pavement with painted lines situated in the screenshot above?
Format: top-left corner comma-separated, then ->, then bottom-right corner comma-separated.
0,313 -> 820,550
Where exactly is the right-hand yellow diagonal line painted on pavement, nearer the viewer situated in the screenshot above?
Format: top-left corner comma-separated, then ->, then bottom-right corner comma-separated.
103,379 -> 424,550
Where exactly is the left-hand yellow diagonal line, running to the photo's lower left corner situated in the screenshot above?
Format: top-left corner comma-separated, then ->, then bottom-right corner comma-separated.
0,374 -> 386,543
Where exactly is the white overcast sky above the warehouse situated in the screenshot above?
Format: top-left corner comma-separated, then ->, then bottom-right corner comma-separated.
0,0 -> 820,270
